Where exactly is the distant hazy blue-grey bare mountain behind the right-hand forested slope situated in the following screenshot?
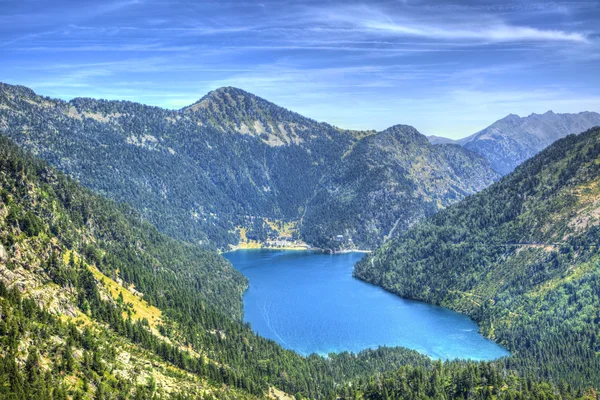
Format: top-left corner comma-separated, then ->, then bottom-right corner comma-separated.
458,111 -> 600,175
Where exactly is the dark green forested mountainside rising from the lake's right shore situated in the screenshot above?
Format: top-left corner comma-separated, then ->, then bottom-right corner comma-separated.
354,128 -> 600,387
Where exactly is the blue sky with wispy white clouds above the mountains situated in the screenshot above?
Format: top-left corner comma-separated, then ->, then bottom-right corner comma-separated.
0,0 -> 600,138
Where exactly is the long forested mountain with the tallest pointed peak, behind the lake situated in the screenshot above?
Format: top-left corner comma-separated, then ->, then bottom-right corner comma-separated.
0,85 -> 353,246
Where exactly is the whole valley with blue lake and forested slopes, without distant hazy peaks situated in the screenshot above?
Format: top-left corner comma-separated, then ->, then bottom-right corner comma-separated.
0,85 -> 600,399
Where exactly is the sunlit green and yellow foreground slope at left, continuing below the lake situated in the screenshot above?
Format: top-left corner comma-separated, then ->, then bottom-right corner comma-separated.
0,128 -> 589,400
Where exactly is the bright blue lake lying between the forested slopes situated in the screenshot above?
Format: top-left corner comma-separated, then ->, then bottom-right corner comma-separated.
224,250 -> 508,360
